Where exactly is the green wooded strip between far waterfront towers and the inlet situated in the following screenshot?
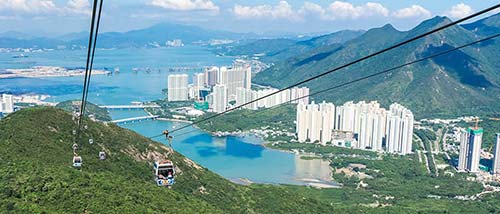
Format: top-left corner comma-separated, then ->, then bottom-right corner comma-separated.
198,105 -> 296,132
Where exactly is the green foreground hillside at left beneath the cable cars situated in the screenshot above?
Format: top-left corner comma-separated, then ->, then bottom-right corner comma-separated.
0,108 -> 345,213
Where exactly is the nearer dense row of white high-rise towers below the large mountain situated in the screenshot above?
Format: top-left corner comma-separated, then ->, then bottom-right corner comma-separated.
296,101 -> 414,155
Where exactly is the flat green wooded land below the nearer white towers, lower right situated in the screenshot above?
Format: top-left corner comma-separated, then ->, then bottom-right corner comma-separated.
273,143 -> 500,213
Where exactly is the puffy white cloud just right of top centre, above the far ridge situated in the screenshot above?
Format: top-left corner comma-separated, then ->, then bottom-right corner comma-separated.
233,1 -> 300,20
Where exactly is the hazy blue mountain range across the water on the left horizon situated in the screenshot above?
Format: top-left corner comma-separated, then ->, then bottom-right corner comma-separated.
0,23 -> 258,48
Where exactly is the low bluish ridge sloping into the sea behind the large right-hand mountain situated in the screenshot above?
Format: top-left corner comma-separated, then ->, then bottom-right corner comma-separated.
217,30 -> 364,62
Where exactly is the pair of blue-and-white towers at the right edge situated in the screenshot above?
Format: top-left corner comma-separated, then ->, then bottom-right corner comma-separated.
457,126 -> 500,175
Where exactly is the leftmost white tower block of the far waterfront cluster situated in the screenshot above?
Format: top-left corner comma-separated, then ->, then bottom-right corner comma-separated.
167,74 -> 189,101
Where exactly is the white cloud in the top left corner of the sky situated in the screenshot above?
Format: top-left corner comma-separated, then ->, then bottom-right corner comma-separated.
0,0 -> 58,14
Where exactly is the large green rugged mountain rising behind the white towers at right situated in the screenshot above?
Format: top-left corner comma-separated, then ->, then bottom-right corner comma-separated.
254,17 -> 500,118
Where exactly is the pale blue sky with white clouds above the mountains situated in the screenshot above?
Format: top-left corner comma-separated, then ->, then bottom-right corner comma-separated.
0,0 -> 498,35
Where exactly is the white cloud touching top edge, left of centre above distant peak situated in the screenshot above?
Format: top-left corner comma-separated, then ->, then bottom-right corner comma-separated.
149,0 -> 219,12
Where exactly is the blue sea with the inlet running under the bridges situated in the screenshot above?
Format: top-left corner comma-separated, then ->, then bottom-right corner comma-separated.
0,46 -> 333,185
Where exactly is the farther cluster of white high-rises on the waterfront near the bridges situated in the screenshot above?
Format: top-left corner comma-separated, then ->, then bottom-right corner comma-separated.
167,63 -> 309,113
